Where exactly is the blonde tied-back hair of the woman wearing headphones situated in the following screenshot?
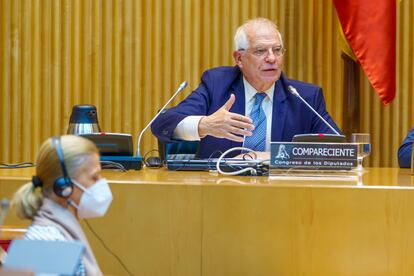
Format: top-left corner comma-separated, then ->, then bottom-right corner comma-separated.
12,135 -> 99,219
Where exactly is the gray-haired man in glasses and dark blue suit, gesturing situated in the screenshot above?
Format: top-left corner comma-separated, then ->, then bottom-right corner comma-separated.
151,18 -> 338,158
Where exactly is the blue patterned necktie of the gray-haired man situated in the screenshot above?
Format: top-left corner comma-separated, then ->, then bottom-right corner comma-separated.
244,93 -> 267,151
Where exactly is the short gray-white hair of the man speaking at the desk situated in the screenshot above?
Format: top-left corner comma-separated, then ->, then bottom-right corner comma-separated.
234,17 -> 283,51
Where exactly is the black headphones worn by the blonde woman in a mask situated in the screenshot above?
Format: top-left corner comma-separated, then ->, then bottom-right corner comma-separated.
52,136 -> 73,198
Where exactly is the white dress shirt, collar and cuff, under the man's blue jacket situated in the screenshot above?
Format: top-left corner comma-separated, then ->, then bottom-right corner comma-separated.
173,77 -> 275,151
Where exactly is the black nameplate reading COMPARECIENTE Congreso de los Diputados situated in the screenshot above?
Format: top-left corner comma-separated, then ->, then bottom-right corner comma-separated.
270,142 -> 358,170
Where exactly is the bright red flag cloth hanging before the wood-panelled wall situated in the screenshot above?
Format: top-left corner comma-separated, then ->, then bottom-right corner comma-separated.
333,0 -> 397,104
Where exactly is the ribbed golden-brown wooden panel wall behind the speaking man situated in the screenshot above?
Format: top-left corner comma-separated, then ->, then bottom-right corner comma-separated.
0,0 -> 414,166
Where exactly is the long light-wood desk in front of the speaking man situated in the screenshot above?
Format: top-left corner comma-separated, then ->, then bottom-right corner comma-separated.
0,168 -> 414,276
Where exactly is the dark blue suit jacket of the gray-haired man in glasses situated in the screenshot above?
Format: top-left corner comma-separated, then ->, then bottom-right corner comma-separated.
151,66 -> 338,158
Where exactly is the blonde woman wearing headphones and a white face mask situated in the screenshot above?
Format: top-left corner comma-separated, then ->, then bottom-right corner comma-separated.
12,135 -> 112,275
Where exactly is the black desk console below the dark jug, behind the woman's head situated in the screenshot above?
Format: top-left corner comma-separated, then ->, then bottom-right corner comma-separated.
80,132 -> 142,170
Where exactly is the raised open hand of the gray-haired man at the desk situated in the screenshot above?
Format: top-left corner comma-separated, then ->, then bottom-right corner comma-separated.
198,94 -> 254,142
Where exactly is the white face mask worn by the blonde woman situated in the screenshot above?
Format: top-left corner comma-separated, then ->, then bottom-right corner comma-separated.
70,178 -> 112,218
